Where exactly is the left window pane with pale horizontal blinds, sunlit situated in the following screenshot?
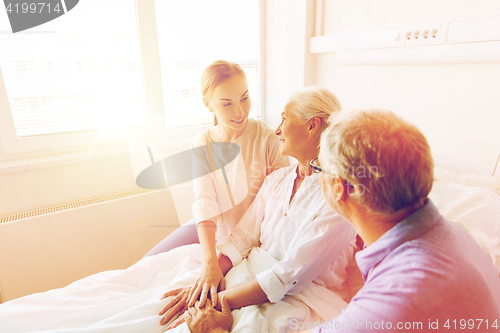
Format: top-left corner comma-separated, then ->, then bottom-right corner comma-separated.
0,0 -> 147,138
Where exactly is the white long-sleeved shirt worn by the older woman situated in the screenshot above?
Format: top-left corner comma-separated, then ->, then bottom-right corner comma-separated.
218,166 -> 356,303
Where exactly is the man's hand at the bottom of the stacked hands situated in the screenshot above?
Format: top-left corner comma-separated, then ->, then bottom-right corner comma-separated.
183,296 -> 233,333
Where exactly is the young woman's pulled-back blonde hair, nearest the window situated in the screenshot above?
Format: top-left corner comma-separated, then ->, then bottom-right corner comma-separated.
201,60 -> 246,125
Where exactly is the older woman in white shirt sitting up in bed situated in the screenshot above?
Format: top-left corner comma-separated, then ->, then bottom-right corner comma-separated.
159,88 -> 356,328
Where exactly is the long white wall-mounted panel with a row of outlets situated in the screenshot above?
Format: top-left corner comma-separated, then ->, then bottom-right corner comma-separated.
309,16 -> 500,65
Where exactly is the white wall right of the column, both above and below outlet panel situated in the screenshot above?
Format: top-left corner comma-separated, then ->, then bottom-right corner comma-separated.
316,0 -> 500,176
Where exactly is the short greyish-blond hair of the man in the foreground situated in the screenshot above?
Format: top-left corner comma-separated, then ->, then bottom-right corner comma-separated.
320,109 -> 434,215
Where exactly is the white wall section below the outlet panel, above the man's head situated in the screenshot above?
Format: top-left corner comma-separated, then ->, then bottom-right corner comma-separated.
318,55 -> 500,176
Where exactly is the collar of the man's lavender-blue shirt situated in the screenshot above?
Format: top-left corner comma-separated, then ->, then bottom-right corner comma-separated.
356,199 -> 442,281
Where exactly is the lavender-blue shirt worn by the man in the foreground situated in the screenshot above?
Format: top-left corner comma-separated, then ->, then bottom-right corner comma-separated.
315,200 -> 500,333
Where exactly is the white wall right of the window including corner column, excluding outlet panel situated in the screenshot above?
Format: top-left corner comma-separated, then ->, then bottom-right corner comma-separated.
266,0 -> 500,177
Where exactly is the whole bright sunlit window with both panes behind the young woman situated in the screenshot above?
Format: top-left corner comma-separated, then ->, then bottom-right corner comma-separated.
0,0 -> 261,153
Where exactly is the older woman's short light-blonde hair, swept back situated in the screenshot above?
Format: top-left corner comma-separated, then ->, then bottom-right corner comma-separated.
285,86 -> 341,132
